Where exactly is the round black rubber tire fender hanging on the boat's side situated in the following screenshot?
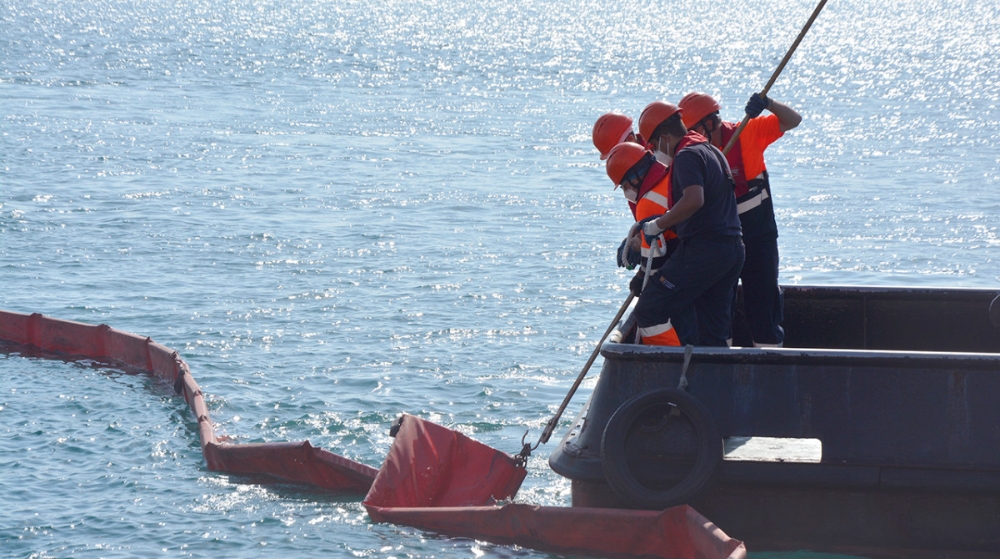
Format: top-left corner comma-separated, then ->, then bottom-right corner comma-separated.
601,388 -> 722,510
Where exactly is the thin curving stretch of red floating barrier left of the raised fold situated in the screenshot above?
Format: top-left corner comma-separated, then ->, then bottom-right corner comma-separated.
0,310 -> 378,493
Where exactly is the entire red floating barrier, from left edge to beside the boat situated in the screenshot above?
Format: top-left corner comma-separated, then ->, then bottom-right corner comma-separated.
0,311 -> 746,559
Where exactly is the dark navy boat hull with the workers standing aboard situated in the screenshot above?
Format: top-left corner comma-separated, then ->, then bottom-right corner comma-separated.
550,287 -> 1000,557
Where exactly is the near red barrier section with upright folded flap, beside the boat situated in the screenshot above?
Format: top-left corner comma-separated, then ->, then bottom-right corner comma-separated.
364,415 -> 746,559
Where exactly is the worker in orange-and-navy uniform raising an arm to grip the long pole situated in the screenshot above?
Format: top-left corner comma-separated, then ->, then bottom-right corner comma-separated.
679,92 -> 802,347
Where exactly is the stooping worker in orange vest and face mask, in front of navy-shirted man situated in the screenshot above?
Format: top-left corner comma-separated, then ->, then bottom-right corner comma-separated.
606,142 -> 680,345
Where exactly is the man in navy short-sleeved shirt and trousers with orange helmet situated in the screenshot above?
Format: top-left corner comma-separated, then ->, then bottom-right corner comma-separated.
634,101 -> 744,347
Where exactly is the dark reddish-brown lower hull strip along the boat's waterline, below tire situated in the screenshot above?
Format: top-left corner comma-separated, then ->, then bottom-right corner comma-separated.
572,480 -> 1000,559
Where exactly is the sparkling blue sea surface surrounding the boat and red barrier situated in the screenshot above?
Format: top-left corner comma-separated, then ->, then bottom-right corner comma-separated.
0,0 -> 1000,559
